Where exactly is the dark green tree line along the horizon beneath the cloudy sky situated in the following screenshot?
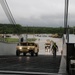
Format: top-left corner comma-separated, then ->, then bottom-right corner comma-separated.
0,24 -> 75,34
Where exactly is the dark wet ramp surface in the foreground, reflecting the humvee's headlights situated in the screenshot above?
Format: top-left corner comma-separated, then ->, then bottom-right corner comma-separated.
0,55 -> 61,73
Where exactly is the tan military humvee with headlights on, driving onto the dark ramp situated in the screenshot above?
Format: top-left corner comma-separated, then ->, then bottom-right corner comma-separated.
16,42 -> 39,56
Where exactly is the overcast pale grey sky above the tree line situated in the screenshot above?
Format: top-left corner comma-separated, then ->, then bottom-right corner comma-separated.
0,0 -> 75,27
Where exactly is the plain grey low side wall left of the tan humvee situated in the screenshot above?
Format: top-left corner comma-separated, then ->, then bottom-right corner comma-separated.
0,43 -> 17,55
